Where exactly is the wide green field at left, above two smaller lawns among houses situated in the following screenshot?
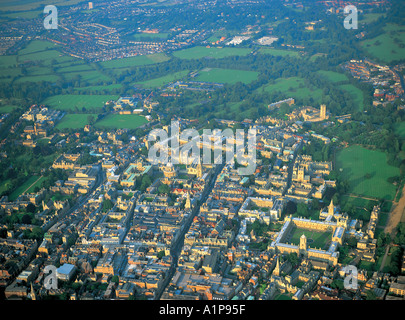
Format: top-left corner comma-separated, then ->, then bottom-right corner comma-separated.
42,94 -> 119,112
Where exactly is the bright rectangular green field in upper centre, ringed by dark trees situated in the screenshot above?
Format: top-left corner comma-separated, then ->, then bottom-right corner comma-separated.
194,68 -> 259,84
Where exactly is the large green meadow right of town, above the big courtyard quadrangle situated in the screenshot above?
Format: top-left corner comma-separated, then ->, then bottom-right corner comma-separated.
336,146 -> 399,200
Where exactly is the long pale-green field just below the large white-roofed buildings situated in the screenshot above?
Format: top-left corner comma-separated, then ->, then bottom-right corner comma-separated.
172,46 -> 251,59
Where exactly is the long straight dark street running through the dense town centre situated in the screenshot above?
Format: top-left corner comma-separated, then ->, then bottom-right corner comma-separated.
155,164 -> 224,300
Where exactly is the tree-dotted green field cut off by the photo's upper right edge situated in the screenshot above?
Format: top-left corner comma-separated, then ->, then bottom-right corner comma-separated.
360,24 -> 405,63
